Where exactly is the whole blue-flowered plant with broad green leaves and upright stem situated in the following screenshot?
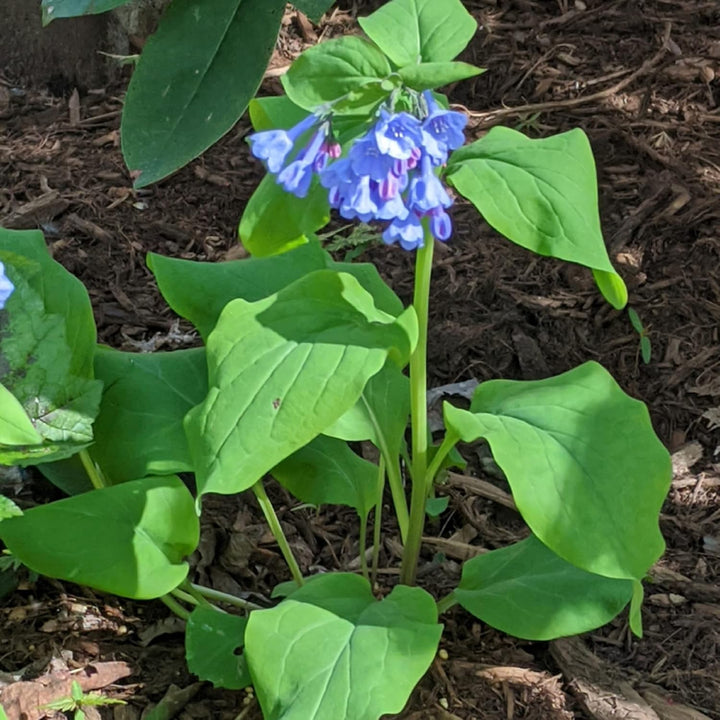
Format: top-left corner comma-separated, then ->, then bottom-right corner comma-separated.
0,0 -> 670,720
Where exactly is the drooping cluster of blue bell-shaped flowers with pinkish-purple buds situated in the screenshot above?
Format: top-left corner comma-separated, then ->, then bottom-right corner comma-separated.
249,92 -> 467,250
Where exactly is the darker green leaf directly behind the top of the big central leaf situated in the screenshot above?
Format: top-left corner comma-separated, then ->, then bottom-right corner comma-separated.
147,242 -> 403,340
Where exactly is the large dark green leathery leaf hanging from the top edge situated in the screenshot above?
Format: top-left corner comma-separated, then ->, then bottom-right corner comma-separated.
121,0 -> 285,187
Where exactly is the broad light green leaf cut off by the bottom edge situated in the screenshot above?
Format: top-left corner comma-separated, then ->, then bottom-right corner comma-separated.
245,573 -> 442,720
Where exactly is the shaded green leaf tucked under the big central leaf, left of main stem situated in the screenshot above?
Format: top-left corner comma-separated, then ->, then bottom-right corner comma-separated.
270,435 -> 378,518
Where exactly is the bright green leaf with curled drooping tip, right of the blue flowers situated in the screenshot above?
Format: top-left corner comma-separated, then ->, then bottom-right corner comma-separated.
447,127 -> 627,307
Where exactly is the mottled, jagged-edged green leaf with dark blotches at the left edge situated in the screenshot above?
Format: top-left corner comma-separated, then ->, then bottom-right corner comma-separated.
0,268 -> 102,465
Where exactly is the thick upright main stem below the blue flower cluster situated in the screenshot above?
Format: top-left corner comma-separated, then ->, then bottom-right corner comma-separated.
400,231 -> 434,585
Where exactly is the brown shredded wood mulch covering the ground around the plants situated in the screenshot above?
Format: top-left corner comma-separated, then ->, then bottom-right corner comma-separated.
0,0 -> 720,720
